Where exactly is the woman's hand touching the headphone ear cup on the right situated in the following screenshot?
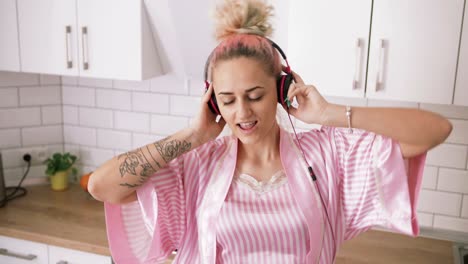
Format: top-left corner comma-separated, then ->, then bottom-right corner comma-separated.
286,69 -> 328,124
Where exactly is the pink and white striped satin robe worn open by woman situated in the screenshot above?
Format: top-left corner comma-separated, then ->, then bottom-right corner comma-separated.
105,126 -> 426,264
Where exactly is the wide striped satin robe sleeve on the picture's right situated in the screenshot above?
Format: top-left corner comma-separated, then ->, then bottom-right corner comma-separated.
328,128 -> 427,240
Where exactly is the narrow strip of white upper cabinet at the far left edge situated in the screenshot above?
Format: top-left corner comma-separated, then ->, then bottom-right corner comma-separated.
0,0 -> 20,71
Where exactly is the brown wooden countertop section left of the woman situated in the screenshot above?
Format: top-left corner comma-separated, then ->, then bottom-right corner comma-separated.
0,185 -> 110,256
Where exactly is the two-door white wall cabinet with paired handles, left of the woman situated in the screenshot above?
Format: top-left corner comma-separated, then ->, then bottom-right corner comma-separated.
18,0 -> 162,80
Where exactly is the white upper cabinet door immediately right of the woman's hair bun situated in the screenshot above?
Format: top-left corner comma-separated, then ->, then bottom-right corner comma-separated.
287,0 -> 372,97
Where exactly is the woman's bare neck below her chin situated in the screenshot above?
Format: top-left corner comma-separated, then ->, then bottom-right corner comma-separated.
238,123 -> 280,163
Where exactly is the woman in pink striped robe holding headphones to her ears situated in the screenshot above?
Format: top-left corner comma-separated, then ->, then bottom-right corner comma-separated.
89,0 -> 452,263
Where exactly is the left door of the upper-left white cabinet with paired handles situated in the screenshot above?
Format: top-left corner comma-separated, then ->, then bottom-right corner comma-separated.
18,0 -> 78,75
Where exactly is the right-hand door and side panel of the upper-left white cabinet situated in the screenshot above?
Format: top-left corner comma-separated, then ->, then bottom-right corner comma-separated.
77,0 -> 161,80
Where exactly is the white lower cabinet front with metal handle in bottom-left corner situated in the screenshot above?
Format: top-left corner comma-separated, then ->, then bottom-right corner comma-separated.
0,236 -> 48,264
